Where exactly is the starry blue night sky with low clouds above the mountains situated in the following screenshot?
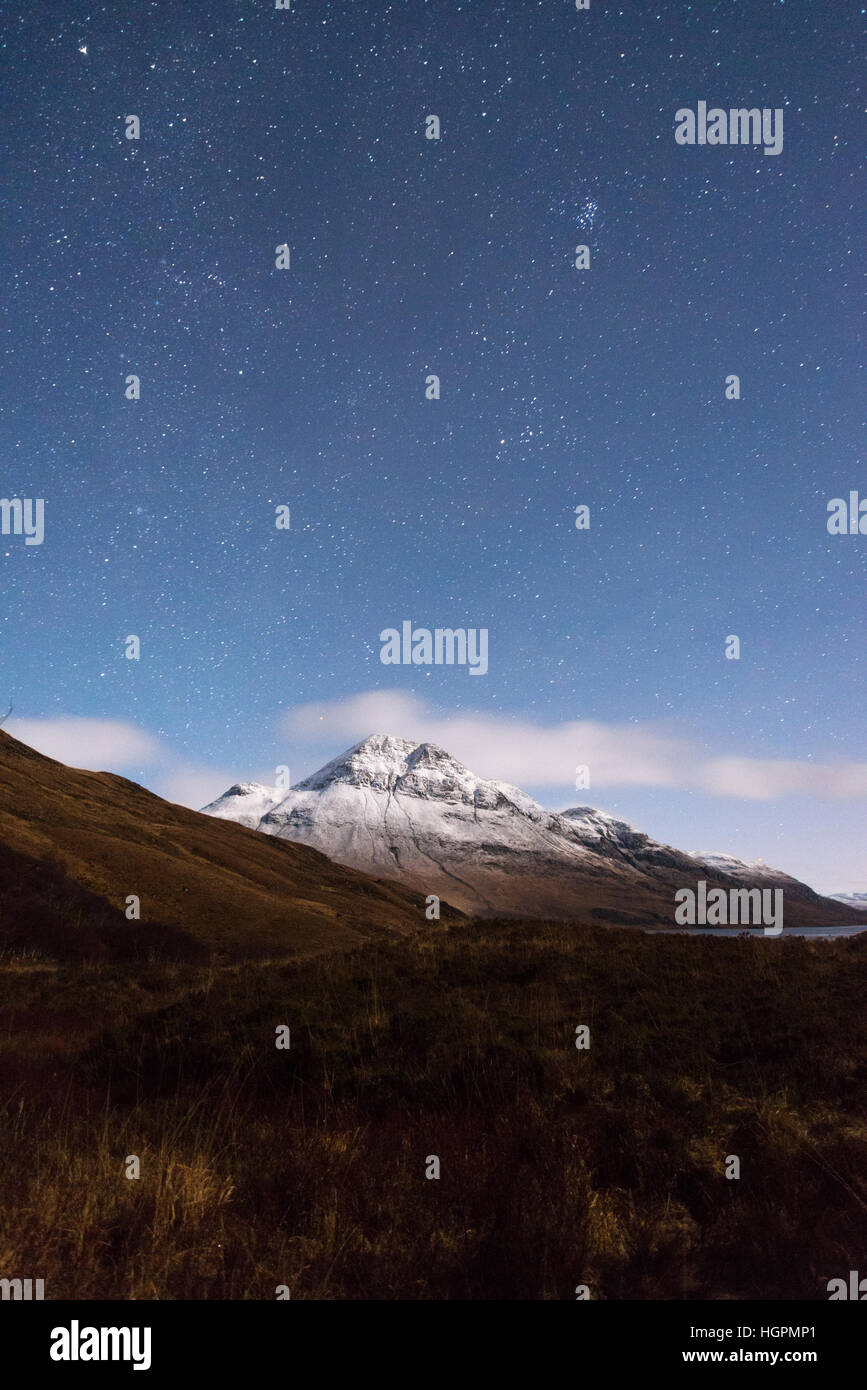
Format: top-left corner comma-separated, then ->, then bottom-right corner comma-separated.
0,0 -> 867,891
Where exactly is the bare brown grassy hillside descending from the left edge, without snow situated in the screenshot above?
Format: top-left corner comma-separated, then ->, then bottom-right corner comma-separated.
0,733 -> 461,959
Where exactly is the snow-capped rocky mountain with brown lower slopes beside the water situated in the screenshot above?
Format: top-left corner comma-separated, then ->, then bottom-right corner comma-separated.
203,734 -> 855,924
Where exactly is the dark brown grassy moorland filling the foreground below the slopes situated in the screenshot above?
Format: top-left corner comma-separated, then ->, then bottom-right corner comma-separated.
0,922 -> 867,1300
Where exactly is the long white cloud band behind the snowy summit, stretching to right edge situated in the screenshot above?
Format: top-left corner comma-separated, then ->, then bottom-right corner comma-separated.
282,691 -> 867,801
